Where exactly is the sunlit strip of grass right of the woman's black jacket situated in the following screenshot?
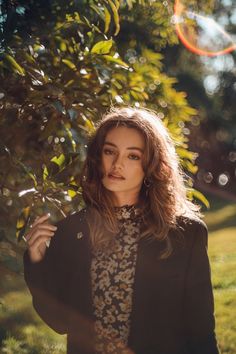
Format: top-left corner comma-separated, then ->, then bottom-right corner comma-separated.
205,199 -> 236,354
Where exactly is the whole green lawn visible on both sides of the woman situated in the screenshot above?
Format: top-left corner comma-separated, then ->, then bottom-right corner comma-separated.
0,198 -> 236,354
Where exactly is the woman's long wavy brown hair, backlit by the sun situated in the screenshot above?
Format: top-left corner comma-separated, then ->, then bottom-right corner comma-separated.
81,107 -> 200,258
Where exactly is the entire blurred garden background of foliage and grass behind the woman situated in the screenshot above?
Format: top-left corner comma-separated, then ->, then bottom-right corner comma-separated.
0,0 -> 236,354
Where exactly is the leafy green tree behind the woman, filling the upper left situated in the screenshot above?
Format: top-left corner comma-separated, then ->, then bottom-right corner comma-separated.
0,0 -> 203,272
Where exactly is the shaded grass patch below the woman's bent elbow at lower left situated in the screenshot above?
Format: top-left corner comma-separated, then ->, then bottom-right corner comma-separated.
0,266 -> 66,354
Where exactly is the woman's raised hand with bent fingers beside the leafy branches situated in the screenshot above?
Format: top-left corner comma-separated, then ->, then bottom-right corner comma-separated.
25,214 -> 57,263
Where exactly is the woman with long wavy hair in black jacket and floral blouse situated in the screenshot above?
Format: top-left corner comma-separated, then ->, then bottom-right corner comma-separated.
24,108 -> 218,354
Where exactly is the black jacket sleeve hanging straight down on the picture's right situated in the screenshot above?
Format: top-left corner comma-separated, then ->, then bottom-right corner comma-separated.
184,222 -> 219,354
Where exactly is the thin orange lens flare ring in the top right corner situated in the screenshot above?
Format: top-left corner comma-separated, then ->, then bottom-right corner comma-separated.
174,0 -> 236,57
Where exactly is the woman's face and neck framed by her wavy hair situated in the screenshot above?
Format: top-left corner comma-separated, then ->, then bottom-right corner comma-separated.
102,127 -> 145,205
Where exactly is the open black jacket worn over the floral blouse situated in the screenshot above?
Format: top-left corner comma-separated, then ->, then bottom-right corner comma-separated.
24,210 -> 219,354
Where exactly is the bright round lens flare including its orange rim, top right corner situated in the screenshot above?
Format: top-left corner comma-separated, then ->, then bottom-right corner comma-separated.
172,0 -> 236,57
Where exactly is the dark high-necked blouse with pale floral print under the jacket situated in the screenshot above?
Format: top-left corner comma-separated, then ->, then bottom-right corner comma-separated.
91,205 -> 141,354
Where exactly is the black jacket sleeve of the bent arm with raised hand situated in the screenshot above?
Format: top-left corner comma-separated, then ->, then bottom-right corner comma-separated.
24,218 -> 72,334
